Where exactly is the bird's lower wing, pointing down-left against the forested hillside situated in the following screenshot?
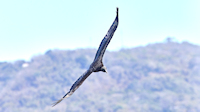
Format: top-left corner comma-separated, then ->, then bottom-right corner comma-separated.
52,70 -> 92,107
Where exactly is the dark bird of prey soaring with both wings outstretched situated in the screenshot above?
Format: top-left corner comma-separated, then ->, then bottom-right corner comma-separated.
53,8 -> 118,106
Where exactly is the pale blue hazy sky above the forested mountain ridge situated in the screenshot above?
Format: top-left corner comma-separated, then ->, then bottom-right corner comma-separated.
0,0 -> 200,61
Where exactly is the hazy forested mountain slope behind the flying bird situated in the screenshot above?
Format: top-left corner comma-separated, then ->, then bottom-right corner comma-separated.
0,41 -> 200,112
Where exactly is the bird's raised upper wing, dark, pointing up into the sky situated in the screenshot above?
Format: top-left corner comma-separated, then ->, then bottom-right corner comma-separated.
94,8 -> 118,61
